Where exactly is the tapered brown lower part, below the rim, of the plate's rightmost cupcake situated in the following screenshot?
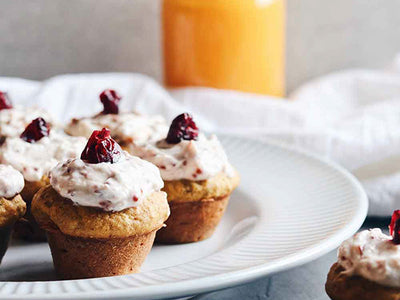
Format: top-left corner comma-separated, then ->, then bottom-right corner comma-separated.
156,195 -> 229,244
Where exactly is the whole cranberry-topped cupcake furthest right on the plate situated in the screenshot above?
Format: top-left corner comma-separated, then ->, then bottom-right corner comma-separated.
128,113 -> 239,243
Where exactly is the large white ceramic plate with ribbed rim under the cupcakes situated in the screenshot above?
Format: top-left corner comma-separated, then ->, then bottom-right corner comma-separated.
0,136 -> 367,299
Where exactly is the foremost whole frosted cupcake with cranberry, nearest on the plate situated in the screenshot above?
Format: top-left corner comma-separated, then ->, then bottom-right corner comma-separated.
32,128 -> 169,279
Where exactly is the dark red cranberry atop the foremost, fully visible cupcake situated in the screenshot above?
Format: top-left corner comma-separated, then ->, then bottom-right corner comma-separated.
81,128 -> 122,164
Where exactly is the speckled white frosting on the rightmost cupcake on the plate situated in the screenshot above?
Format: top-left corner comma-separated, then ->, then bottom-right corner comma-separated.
129,134 -> 235,180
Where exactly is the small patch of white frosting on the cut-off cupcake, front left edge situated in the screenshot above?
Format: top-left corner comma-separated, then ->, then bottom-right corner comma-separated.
0,165 -> 25,198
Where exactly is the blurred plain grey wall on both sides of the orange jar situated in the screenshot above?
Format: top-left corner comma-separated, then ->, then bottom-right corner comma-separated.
0,0 -> 400,92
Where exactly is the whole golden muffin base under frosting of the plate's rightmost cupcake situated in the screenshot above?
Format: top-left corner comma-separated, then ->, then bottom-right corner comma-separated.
156,173 -> 240,244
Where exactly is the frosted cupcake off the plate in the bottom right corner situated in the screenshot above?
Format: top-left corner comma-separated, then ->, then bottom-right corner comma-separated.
325,210 -> 400,300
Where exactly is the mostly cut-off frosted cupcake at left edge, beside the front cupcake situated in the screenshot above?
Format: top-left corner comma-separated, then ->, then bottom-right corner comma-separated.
0,165 -> 26,262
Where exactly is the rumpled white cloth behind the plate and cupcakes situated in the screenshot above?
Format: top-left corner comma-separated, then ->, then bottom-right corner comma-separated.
0,58 -> 400,216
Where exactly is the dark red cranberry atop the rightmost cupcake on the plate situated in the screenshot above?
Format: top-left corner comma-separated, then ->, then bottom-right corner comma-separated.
166,113 -> 199,144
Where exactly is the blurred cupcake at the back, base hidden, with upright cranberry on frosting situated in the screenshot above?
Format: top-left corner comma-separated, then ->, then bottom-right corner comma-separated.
65,90 -> 168,147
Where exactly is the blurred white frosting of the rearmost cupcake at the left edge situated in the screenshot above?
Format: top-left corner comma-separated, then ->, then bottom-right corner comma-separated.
0,106 -> 53,137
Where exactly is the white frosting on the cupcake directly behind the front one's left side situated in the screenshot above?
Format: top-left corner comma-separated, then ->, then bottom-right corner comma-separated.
0,132 -> 87,181
